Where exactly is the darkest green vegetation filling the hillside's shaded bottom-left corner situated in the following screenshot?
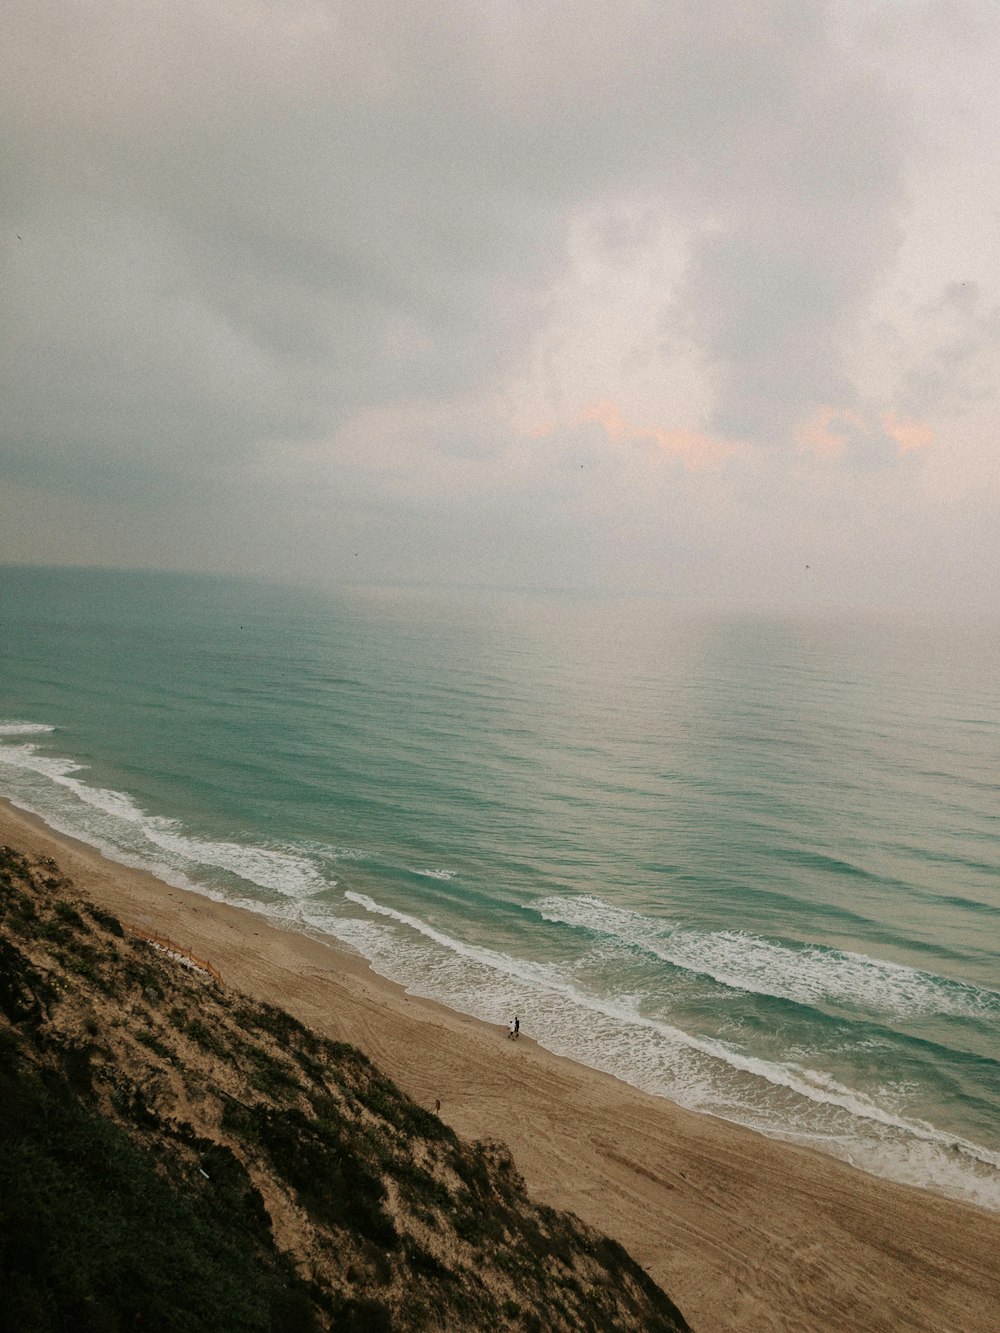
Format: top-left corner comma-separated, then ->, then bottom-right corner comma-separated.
0,1060 -> 317,1333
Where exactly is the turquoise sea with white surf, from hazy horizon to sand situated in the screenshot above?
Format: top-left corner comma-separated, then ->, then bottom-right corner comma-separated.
0,568 -> 1000,1209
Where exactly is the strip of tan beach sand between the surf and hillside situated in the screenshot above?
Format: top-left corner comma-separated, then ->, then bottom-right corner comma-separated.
0,802 -> 1000,1333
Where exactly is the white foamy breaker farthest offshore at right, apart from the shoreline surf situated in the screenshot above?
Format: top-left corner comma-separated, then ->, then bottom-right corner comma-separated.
528,894 -> 1000,1018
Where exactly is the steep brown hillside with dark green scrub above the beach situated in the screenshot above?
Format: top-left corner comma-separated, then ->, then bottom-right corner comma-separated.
0,848 -> 687,1333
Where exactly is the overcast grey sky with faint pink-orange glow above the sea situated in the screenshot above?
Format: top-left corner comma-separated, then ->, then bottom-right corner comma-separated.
0,0 -> 1000,613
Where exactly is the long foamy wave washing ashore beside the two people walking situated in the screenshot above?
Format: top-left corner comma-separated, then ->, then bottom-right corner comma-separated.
334,890 -> 1000,1209
